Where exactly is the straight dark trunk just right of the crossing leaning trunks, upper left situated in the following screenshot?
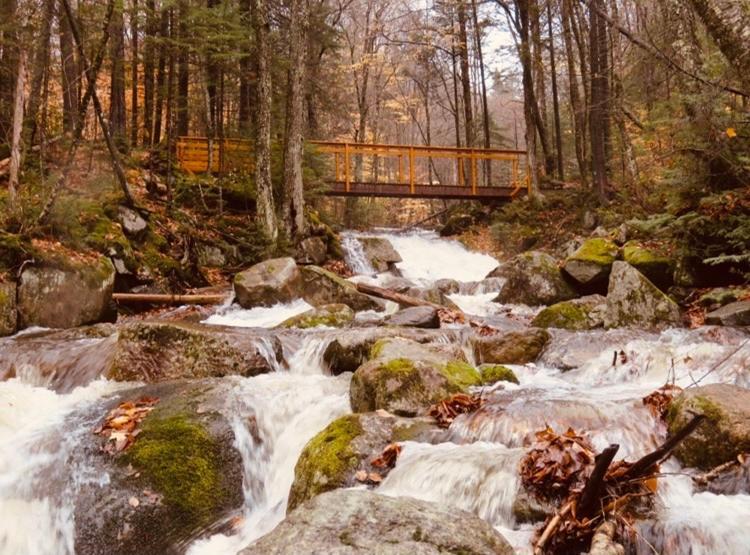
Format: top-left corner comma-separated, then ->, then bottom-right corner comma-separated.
109,2 -> 128,151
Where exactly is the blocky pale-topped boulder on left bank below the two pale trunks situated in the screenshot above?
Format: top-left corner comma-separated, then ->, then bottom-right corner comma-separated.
234,257 -> 301,308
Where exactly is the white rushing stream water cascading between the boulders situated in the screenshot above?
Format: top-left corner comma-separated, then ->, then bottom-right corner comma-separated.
0,230 -> 750,555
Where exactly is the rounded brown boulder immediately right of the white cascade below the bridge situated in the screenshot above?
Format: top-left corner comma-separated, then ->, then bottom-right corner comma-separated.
487,251 -> 578,306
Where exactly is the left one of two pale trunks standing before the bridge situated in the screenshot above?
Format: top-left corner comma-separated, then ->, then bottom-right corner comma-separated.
252,0 -> 279,244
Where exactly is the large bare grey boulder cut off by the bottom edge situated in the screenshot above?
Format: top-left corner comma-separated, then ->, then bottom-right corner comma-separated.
240,490 -> 514,555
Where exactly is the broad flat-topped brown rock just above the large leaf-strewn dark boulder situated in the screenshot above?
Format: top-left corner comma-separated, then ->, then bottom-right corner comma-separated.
106,322 -> 282,382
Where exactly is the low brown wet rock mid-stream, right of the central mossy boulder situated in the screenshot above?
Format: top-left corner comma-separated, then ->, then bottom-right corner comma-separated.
473,328 -> 550,364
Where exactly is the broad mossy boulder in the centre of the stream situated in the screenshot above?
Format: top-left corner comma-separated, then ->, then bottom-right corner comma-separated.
349,338 -> 481,416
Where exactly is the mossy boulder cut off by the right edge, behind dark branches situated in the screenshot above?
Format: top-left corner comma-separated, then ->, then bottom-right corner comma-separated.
667,384 -> 750,470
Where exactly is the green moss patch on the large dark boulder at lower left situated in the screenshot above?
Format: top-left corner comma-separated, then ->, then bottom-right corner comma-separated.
124,414 -> 224,524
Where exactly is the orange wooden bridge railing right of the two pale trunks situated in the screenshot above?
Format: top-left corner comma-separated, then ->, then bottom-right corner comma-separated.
310,141 -> 529,195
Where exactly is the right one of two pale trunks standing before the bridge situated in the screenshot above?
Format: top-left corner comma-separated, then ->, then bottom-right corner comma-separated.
283,0 -> 309,239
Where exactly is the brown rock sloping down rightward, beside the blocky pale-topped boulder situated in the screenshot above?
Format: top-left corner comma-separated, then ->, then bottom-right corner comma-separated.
299,266 -> 382,312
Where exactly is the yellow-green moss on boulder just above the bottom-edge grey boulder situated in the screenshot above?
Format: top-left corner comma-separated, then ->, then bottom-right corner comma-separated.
287,414 -> 363,511
